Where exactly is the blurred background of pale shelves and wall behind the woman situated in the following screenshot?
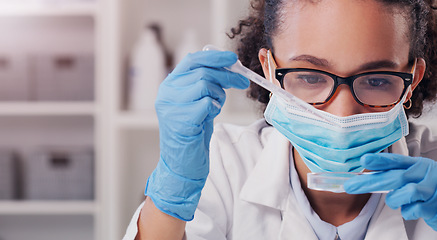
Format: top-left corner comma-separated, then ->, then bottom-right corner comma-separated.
0,0 -> 437,240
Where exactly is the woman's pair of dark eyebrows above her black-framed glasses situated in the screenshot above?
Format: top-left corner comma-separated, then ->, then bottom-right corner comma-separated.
290,54 -> 399,72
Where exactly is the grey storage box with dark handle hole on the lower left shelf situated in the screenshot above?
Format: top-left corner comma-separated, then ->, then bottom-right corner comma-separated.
22,147 -> 94,200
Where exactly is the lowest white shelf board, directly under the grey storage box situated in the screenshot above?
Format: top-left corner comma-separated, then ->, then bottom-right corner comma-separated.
0,201 -> 96,215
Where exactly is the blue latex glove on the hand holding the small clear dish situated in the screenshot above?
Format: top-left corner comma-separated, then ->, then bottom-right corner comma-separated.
344,153 -> 437,231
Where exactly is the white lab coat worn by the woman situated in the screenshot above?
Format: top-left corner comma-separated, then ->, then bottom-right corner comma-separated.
124,120 -> 437,240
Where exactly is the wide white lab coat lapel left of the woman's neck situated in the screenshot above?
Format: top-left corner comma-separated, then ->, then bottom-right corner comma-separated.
240,129 -> 291,211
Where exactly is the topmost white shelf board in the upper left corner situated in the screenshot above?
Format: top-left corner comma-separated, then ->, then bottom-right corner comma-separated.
0,1 -> 97,17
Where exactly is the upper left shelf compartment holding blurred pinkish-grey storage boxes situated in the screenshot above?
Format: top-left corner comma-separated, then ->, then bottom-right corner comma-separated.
0,15 -> 96,102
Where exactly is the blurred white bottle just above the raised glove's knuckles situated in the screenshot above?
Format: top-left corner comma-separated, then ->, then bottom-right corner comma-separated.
174,28 -> 202,65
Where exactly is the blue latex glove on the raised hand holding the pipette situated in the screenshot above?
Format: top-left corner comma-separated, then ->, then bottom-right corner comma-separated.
145,51 -> 249,221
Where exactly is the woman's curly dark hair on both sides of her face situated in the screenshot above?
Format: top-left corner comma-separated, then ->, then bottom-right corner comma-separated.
228,0 -> 437,117
